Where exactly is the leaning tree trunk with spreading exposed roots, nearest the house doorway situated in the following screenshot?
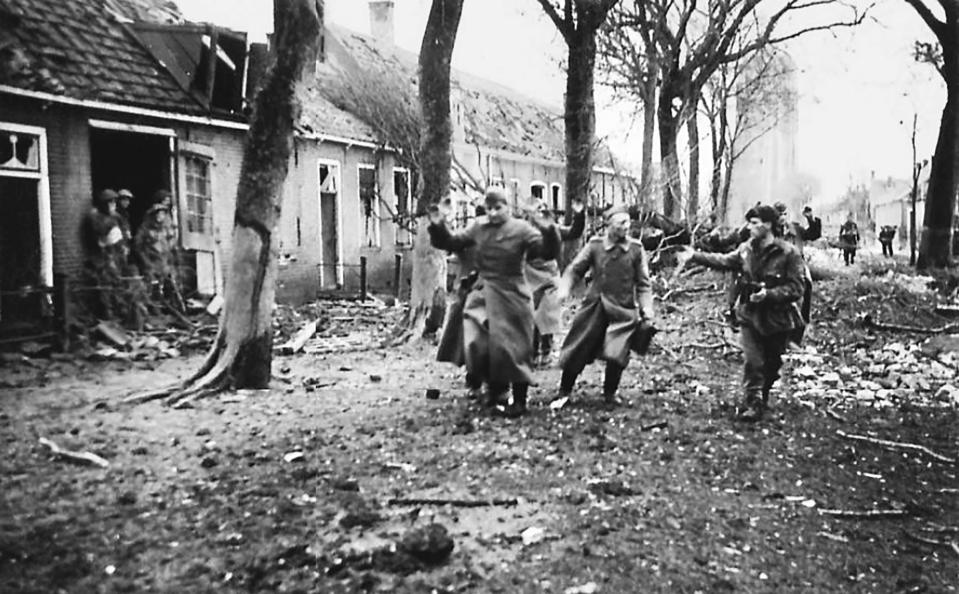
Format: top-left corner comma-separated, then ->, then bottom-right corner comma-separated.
136,0 -> 323,404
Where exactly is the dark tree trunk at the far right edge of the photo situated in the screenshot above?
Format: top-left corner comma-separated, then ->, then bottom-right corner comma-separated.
916,34 -> 959,269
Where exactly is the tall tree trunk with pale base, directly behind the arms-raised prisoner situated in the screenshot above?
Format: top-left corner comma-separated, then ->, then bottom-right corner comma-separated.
407,0 -> 463,335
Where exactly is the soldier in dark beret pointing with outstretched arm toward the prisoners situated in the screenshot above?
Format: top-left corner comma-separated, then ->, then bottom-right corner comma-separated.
680,205 -> 805,422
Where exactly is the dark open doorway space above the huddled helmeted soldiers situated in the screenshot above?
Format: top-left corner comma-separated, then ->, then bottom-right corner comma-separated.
90,128 -> 172,234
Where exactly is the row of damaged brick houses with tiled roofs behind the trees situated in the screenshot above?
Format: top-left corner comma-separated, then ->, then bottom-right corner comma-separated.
0,0 -> 631,330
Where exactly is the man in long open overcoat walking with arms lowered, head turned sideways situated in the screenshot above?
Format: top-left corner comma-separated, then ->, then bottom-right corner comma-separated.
559,208 -> 653,404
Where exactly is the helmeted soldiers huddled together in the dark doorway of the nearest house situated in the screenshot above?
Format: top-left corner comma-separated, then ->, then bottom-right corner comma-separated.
81,189 -> 180,319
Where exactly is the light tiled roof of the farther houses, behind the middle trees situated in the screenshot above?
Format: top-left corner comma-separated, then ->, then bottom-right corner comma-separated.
326,24 -> 565,163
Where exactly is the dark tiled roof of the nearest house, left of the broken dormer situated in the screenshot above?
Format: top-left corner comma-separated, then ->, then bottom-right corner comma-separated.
0,0 -> 204,113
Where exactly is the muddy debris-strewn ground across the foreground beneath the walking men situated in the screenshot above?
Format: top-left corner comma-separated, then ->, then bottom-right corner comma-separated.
0,251 -> 959,593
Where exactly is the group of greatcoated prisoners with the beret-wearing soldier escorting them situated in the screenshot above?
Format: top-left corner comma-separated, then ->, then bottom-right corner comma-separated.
428,188 -> 821,421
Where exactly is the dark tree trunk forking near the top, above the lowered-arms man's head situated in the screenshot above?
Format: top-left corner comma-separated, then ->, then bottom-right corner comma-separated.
563,23 -> 596,220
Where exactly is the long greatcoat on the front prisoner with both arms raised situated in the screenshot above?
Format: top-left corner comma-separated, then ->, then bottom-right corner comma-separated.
428,216 -> 559,384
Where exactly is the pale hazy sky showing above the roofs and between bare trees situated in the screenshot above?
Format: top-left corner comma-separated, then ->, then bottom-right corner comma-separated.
176,0 -> 945,199
